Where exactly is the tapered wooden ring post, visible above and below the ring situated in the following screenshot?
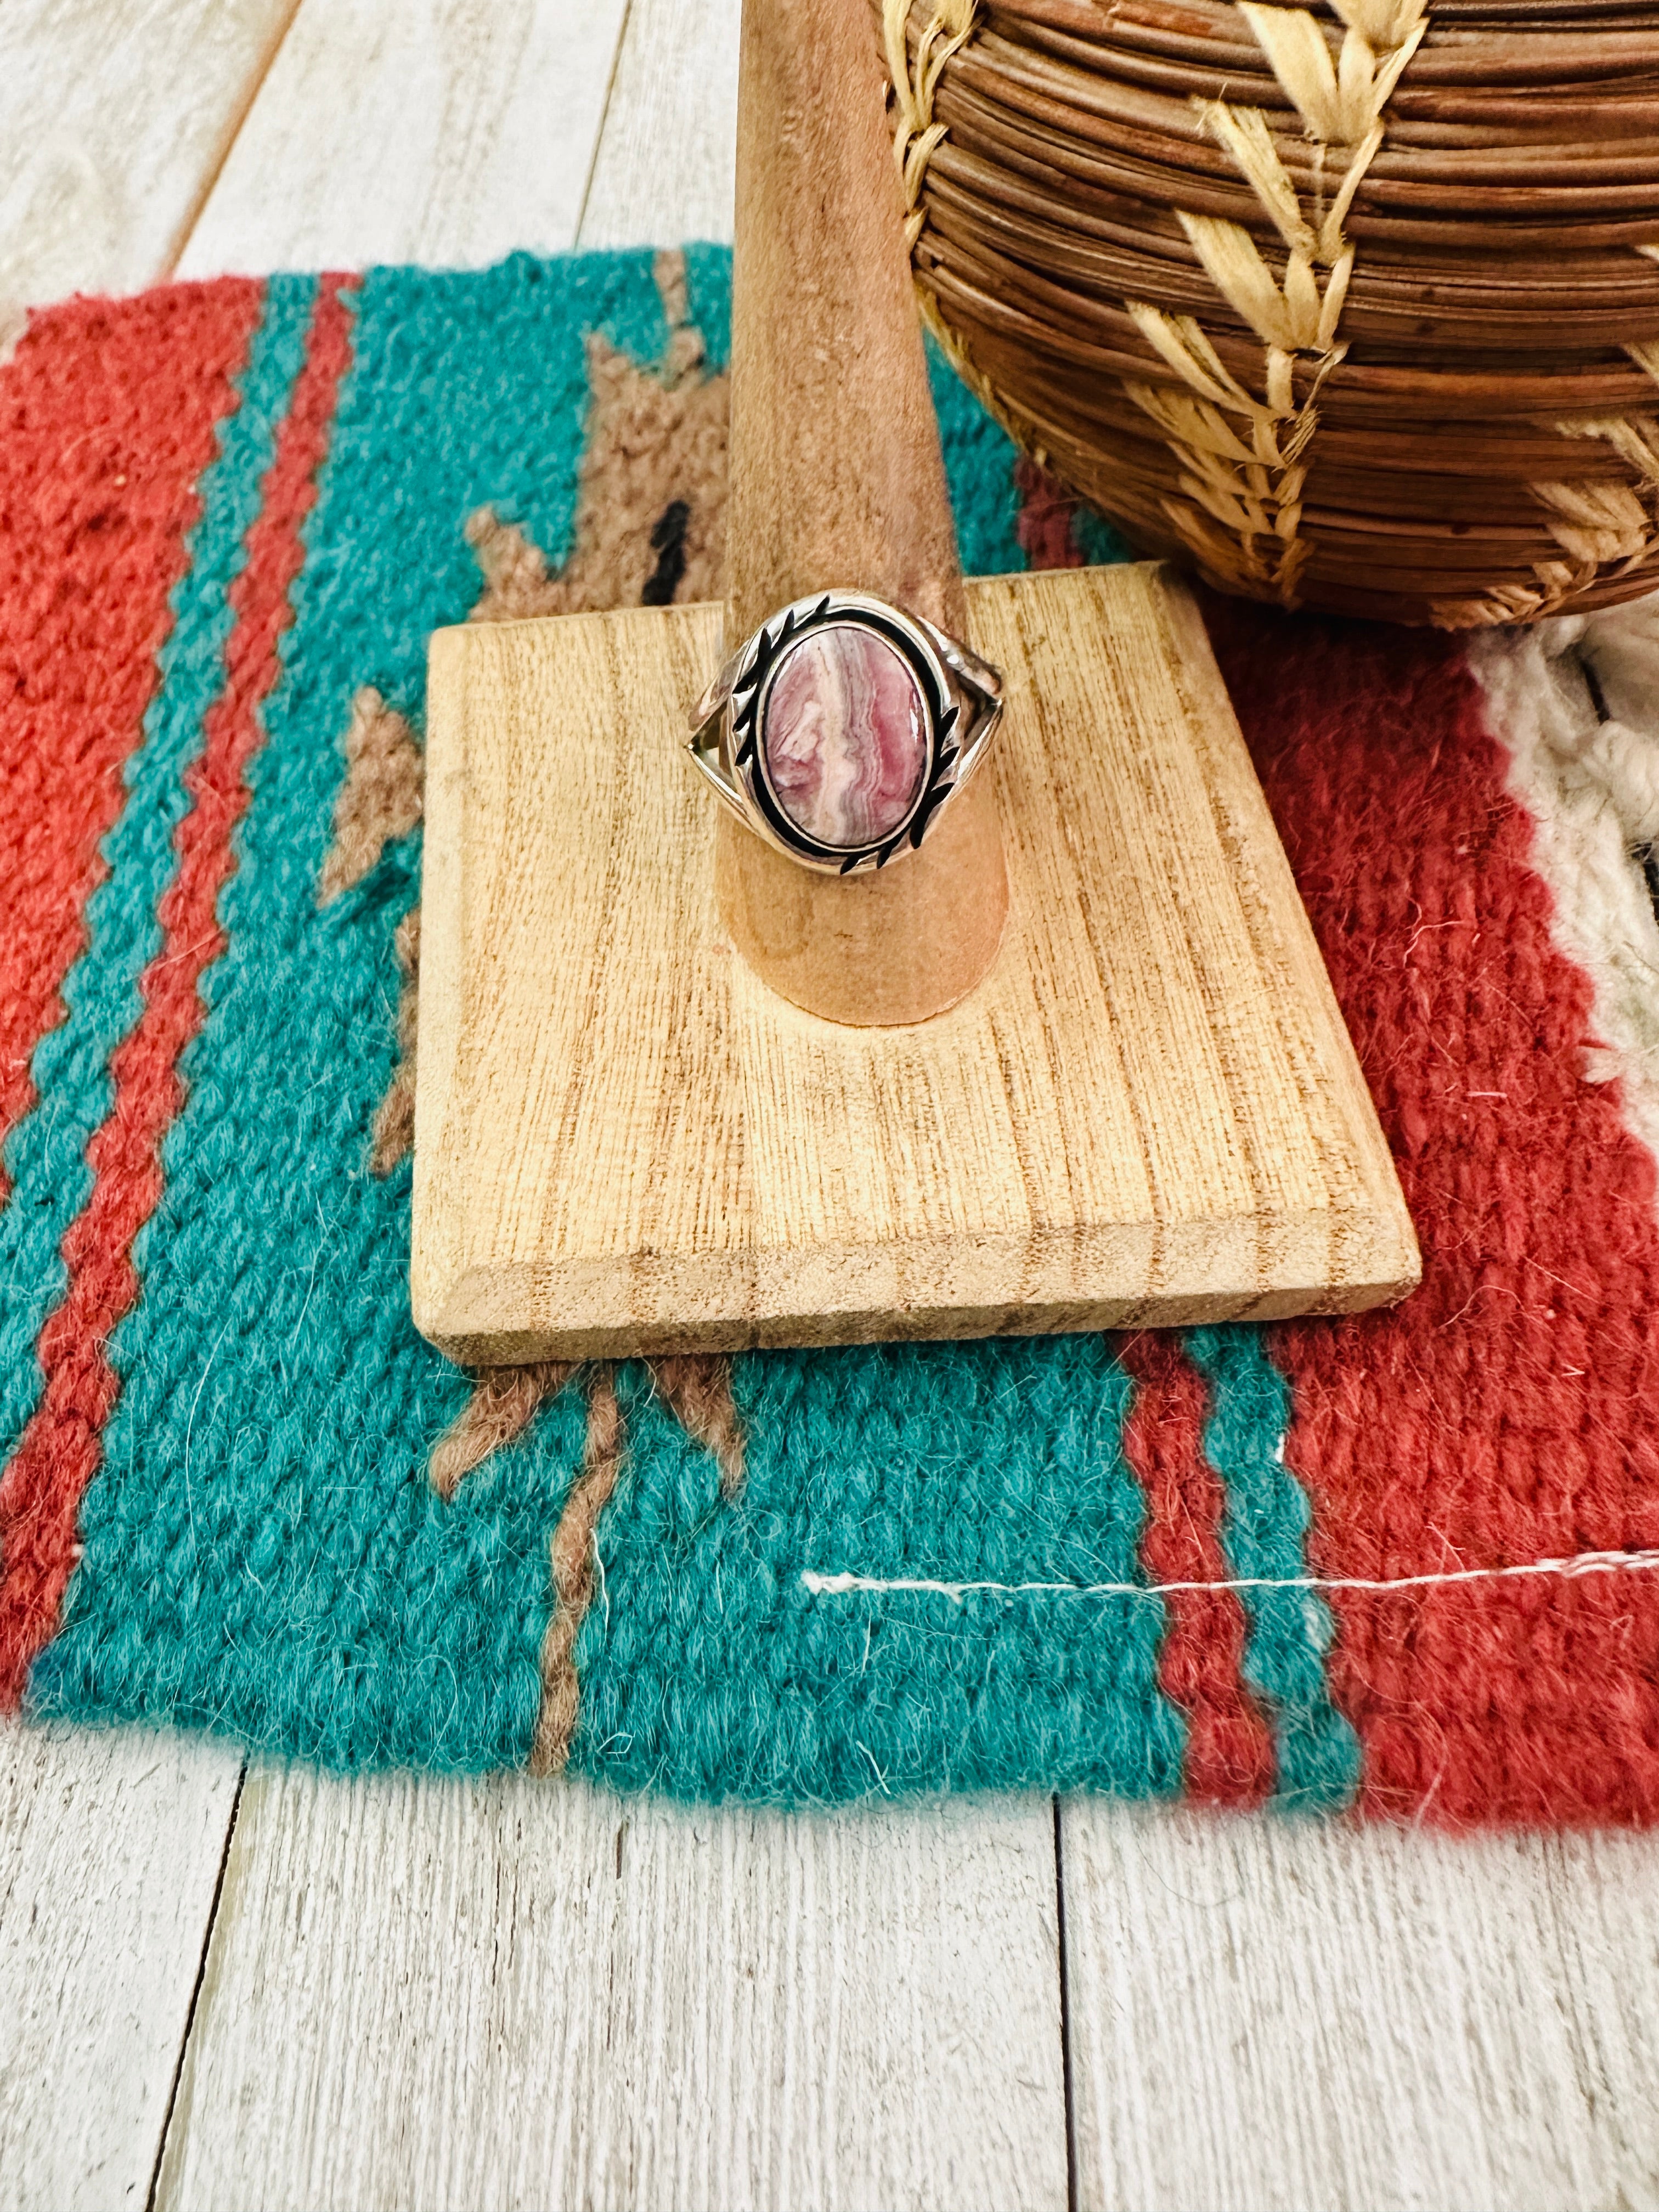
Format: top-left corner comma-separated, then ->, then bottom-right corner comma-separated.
714,0 -> 1009,1026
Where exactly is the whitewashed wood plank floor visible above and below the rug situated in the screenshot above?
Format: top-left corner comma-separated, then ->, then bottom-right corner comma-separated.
0,0 -> 1659,2212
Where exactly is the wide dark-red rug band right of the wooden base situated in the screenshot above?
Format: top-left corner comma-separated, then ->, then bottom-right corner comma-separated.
1210,606 -> 1659,1822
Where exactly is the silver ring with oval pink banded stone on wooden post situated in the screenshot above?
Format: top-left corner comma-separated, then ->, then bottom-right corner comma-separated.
688,591 -> 1002,876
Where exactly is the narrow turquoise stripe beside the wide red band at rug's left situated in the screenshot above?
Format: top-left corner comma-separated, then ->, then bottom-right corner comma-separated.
0,276 -> 317,1464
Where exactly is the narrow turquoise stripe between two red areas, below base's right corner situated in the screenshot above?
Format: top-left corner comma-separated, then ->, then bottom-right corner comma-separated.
1186,1325 -> 1361,1809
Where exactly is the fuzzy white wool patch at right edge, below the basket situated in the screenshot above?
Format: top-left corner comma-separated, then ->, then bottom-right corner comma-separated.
1469,593 -> 1659,1186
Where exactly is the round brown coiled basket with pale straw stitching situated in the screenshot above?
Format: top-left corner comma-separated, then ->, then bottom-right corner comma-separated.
876,0 -> 1659,628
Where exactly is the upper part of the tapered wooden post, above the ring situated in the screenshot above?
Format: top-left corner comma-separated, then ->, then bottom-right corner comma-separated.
725,0 -> 967,646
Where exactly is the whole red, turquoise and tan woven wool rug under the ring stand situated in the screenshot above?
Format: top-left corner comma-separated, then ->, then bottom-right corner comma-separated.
0,248 -> 1659,1822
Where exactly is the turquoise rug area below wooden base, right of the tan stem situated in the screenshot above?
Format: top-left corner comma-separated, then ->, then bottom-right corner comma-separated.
571,1336 -> 1186,1803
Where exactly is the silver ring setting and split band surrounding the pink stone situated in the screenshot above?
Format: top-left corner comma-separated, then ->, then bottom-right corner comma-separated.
688,591 -> 1002,876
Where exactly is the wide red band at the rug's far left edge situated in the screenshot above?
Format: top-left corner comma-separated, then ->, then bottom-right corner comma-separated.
0,279 -> 261,1201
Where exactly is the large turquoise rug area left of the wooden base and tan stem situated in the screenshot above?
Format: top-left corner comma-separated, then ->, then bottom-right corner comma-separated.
31,255 -> 668,1768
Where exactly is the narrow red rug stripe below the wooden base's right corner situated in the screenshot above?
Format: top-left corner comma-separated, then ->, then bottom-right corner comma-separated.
1115,1334 -> 1274,1805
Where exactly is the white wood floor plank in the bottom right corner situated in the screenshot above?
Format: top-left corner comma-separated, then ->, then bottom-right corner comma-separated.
1062,1803 -> 1659,2212
